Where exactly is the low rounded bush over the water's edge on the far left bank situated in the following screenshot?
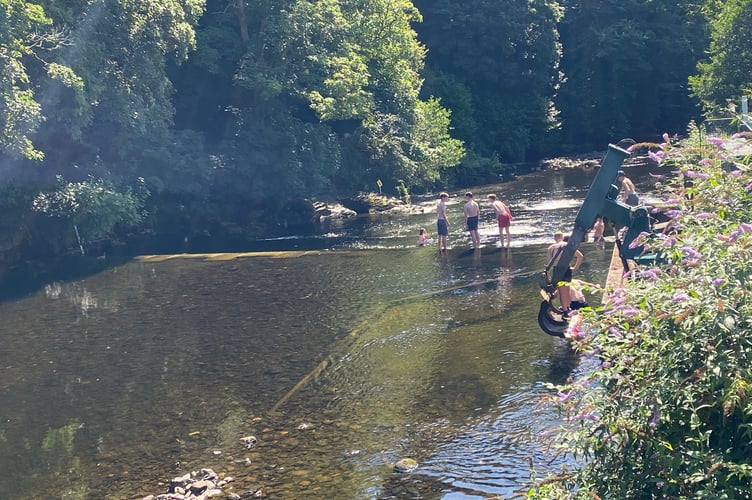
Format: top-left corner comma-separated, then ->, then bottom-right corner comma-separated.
33,176 -> 148,246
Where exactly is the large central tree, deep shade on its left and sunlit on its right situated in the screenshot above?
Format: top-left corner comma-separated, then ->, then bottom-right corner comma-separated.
184,0 -> 461,203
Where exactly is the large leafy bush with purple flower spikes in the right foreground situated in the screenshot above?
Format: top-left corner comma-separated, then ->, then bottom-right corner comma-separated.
528,125 -> 752,499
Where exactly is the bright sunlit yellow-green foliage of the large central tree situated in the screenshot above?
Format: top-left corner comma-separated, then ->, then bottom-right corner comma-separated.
283,0 -> 462,185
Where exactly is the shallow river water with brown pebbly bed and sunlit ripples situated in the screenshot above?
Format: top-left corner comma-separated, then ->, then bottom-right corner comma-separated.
0,158 -> 656,499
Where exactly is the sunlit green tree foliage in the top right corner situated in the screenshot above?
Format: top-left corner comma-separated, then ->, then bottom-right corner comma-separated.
689,0 -> 752,114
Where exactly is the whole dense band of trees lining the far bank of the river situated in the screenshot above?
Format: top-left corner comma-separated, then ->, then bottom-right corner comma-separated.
0,0 -> 752,259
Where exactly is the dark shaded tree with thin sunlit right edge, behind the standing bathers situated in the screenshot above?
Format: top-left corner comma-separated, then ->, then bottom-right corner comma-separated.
415,0 -> 561,162
